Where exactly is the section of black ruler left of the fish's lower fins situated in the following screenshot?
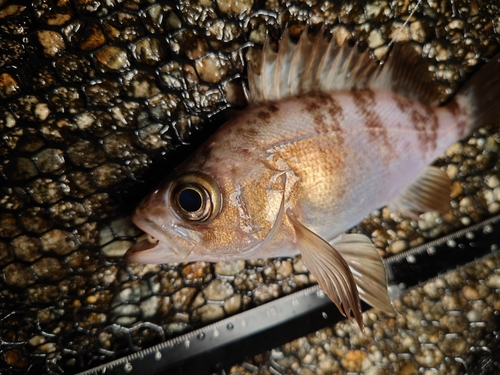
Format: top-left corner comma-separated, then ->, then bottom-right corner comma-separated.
77,285 -> 344,375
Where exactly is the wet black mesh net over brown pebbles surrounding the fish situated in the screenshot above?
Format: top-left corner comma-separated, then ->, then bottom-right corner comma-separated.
0,0 -> 500,374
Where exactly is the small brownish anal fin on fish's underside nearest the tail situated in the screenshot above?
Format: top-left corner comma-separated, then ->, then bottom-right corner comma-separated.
389,167 -> 451,219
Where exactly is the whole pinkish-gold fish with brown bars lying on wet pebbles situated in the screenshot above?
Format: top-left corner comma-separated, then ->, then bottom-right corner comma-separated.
125,28 -> 500,330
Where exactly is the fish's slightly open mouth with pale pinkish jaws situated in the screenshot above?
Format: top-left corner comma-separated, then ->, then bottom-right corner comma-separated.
125,212 -> 200,264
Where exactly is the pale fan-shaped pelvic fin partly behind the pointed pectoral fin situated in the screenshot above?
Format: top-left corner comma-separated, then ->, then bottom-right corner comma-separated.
333,234 -> 395,314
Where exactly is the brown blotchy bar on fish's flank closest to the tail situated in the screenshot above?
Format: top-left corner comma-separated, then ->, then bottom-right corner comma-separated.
392,93 -> 439,154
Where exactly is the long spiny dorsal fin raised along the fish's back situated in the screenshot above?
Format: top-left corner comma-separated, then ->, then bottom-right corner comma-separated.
248,28 -> 439,105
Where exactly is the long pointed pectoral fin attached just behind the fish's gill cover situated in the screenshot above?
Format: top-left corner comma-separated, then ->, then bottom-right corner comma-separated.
287,210 -> 364,330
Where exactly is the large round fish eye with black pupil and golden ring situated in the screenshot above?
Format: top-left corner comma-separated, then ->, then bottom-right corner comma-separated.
170,173 -> 222,224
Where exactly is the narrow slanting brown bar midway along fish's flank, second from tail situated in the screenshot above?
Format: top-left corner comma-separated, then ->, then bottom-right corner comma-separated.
351,89 -> 394,162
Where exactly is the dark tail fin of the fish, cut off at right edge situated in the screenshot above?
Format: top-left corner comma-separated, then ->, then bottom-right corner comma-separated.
456,53 -> 500,135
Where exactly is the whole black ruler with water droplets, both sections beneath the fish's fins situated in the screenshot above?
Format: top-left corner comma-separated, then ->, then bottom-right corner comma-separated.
77,215 -> 500,375
